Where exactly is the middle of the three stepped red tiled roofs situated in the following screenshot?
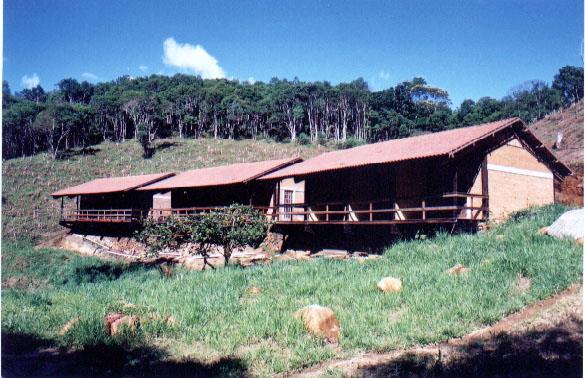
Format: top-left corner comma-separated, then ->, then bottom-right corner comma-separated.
138,158 -> 302,190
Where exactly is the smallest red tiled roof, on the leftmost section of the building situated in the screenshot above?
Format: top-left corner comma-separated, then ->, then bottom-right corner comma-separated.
51,172 -> 174,197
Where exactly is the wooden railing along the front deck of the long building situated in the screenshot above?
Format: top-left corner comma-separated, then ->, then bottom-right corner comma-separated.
61,193 -> 489,224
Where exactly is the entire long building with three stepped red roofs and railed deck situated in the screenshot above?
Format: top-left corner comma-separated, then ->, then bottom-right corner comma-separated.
53,118 -> 571,234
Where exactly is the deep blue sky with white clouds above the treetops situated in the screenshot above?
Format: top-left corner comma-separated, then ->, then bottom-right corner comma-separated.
3,0 -> 583,106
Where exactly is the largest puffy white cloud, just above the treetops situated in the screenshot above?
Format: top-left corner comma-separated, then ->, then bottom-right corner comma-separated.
163,38 -> 225,79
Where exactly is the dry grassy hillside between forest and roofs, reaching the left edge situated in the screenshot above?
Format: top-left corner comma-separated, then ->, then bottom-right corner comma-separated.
2,139 -> 325,239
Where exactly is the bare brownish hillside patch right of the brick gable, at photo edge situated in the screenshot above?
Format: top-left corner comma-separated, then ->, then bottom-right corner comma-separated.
530,100 -> 583,176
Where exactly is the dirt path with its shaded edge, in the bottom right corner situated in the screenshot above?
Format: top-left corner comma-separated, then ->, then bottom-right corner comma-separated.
290,285 -> 583,377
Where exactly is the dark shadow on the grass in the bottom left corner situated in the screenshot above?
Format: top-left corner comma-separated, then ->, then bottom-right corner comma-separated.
2,332 -> 249,377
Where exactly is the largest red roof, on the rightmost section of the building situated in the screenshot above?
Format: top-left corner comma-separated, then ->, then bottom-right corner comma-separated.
260,118 -> 524,180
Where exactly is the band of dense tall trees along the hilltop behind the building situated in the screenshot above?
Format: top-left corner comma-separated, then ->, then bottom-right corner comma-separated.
2,66 -> 583,159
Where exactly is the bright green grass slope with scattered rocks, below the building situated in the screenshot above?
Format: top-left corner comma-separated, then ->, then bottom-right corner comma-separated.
2,206 -> 582,375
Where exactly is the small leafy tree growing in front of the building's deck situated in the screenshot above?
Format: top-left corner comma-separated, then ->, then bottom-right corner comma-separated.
137,205 -> 270,265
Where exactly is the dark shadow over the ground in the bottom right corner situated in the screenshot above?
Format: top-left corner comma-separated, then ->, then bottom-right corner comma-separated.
357,318 -> 583,377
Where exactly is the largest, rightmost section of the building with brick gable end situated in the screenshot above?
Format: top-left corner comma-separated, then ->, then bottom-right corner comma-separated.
260,118 -> 571,225
